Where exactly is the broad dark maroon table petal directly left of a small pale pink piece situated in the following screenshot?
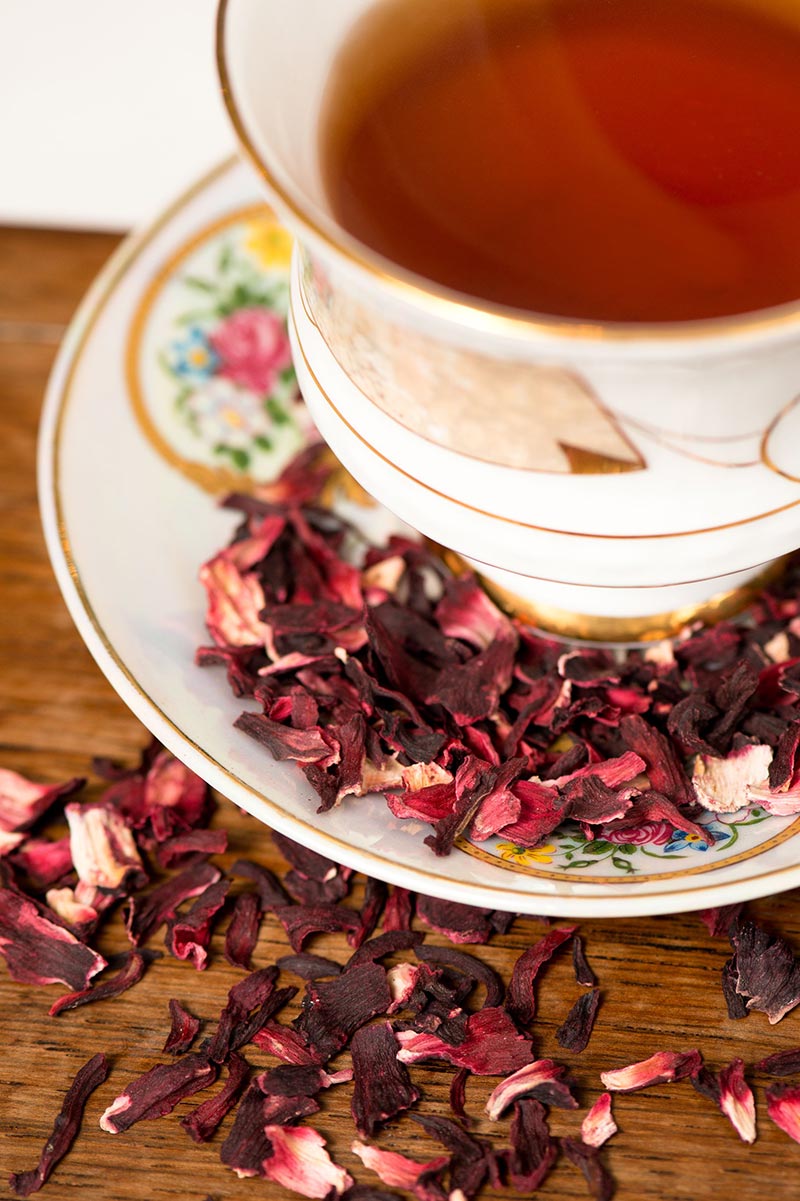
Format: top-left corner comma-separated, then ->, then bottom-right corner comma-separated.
294,963 -> 392,1062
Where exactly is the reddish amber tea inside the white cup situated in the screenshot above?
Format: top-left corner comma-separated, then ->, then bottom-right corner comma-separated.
321,0 -> 800,322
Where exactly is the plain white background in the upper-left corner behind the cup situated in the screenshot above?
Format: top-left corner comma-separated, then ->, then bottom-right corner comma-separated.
0,0 -> 234,229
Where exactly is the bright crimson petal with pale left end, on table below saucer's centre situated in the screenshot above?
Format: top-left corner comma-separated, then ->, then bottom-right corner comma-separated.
396,1008 -> 531,1076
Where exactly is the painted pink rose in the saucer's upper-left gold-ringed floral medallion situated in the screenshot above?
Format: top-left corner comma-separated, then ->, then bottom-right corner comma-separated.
209,309 -> 292,394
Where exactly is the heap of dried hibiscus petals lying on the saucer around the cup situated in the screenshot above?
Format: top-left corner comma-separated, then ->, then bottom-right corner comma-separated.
197,448 -> 800,855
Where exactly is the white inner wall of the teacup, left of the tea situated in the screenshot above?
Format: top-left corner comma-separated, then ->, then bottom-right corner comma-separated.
225,0 -> 367,239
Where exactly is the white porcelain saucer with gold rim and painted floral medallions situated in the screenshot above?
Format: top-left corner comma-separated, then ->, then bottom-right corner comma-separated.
38,161 -> 800,916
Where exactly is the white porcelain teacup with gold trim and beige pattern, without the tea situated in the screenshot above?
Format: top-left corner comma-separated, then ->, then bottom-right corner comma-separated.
217,0 -> 800,640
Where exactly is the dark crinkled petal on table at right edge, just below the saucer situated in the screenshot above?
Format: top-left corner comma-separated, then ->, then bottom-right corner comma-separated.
732,921 -> 800,1023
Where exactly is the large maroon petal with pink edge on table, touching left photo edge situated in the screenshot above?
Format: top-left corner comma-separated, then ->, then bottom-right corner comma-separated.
0,889 -> 106,992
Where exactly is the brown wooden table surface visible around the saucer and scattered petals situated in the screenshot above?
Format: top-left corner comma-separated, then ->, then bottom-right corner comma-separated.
0,229 -> 800,1201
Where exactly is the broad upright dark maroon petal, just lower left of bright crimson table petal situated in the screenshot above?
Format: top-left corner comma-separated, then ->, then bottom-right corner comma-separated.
350,1022 -> 422,1137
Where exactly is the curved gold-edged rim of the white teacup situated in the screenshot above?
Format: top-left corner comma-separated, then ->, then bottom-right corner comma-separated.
215,0 -> 800,342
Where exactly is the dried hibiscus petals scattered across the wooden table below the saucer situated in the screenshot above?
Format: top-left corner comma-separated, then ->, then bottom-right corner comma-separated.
0,743 -> 800,1201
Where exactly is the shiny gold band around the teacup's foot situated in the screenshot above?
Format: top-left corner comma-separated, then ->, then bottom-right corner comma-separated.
431,543 -> 788,644
